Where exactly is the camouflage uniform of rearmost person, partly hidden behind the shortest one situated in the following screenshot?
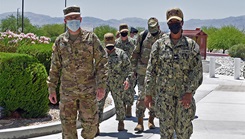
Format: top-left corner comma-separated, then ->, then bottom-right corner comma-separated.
115,23 -> 136,106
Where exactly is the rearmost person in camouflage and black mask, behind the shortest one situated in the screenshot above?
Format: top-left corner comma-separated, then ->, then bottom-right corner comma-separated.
115,24 -> 136,117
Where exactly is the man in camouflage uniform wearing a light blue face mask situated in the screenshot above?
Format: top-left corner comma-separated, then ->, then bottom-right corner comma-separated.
47,6 -> 107,139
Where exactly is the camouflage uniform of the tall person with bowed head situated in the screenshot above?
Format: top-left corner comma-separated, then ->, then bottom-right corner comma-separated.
131,30 -> 165,117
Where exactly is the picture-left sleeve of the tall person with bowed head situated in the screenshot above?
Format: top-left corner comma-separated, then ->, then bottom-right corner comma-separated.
130,34 -> 142,71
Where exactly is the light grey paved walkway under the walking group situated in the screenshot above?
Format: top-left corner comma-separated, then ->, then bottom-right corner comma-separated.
0,73 -> 245,139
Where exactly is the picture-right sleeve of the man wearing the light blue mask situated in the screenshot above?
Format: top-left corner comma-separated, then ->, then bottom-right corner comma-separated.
93,34 -> 108,89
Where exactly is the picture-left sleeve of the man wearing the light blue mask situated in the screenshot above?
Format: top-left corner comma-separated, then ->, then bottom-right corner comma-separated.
47,41 -> 61,93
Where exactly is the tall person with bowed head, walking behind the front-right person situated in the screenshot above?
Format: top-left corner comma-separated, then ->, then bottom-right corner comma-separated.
131,17 -> 165,132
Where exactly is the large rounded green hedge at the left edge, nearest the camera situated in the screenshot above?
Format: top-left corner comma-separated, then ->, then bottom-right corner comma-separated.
0,52 -> 49,118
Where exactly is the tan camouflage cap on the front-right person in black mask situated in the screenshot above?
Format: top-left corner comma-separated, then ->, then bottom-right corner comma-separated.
166,8 -> 183,22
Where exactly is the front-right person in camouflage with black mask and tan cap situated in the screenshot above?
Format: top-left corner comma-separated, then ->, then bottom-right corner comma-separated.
145,8 -> 203,139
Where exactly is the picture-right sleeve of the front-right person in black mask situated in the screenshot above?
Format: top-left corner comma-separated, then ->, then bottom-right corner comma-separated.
186,41 -> 203,95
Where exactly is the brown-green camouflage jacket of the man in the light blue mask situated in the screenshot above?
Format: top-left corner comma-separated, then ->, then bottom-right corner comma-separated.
47,30 -> 107,93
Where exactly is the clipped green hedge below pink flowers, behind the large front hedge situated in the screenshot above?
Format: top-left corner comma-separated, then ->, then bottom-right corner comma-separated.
16,44 -> 52,73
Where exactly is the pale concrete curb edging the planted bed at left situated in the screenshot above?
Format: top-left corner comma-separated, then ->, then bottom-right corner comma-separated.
0,95 -> 116,139
